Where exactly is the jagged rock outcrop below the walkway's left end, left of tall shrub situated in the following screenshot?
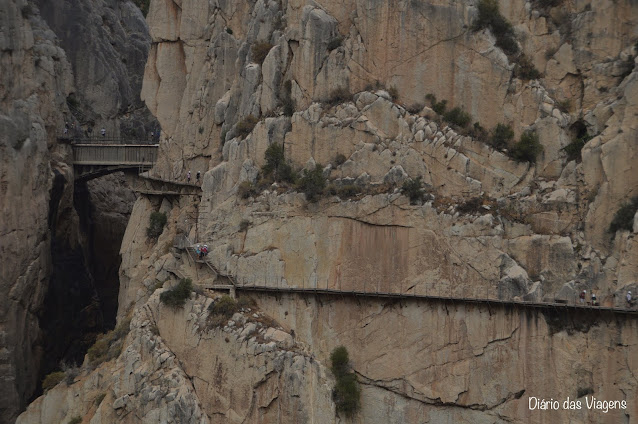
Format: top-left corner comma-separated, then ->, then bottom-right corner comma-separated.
17,290 -> 336,424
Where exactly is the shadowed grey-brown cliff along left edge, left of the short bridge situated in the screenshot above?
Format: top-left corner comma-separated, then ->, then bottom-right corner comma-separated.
0,0 -> 72,422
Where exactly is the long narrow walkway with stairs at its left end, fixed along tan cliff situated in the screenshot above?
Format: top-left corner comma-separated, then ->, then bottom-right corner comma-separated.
181,243 -> 638,318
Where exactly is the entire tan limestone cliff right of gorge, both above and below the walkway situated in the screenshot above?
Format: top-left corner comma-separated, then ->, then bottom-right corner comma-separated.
20,0 -> 638,423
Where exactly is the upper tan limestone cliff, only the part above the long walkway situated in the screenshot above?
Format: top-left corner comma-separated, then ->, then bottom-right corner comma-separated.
142,1 -> 638,304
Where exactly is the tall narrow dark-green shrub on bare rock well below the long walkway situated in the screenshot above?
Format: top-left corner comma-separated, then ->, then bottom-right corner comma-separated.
330,346 -> 361,417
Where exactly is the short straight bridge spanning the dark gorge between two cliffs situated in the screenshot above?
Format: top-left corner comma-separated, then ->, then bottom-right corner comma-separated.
58,137 -> 159,181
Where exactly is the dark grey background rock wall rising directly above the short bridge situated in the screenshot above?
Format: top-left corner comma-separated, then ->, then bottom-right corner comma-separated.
36,0 -> 155,137
